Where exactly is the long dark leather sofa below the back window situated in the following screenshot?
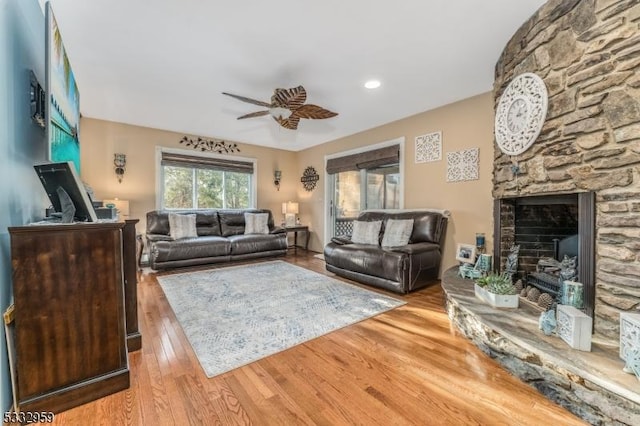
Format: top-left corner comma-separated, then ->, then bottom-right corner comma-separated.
146,209 -> 287,270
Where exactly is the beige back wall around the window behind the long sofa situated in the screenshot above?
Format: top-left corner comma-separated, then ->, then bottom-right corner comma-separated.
80,118 -> 300,232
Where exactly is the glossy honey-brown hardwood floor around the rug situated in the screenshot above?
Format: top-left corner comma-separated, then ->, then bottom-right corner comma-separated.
54,250 -> 584,425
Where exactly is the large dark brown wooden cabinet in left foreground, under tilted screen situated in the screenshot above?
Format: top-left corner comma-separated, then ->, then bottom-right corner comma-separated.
9,222 -> 130,412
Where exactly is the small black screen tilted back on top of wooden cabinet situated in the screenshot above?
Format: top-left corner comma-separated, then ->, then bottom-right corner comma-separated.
33,161 -> 98,222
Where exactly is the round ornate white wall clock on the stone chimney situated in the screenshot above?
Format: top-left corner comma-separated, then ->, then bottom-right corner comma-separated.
495,72 -> 548,155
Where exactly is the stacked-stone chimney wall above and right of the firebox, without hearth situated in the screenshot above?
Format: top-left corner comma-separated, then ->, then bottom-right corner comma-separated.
493,0 -> 640,341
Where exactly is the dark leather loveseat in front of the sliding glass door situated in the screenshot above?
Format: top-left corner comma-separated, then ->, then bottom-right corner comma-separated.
324,210 -> 449,294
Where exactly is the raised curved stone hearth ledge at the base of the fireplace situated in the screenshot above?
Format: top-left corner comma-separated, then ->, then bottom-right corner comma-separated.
442,267 -> 640,425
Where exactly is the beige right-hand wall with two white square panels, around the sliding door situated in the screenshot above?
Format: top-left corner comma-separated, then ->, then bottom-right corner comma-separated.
297,93 -> 494,269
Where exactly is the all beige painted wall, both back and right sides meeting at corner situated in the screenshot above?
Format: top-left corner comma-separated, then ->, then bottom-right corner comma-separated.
81,93 -> 494,268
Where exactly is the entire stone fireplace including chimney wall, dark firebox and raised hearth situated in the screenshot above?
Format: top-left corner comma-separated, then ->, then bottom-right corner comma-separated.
442,0 -> 640,425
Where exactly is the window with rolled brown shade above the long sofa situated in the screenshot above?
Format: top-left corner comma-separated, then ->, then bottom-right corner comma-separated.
160,150 -> 255,209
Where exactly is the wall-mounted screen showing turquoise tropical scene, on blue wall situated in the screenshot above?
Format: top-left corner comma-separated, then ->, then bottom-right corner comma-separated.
45,2 -> 80,173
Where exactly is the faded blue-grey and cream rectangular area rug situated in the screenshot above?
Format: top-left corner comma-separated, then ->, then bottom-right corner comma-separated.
158,261 -> 405,377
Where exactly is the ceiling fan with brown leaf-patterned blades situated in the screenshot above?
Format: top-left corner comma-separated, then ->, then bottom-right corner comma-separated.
222,86 -> 338,130
